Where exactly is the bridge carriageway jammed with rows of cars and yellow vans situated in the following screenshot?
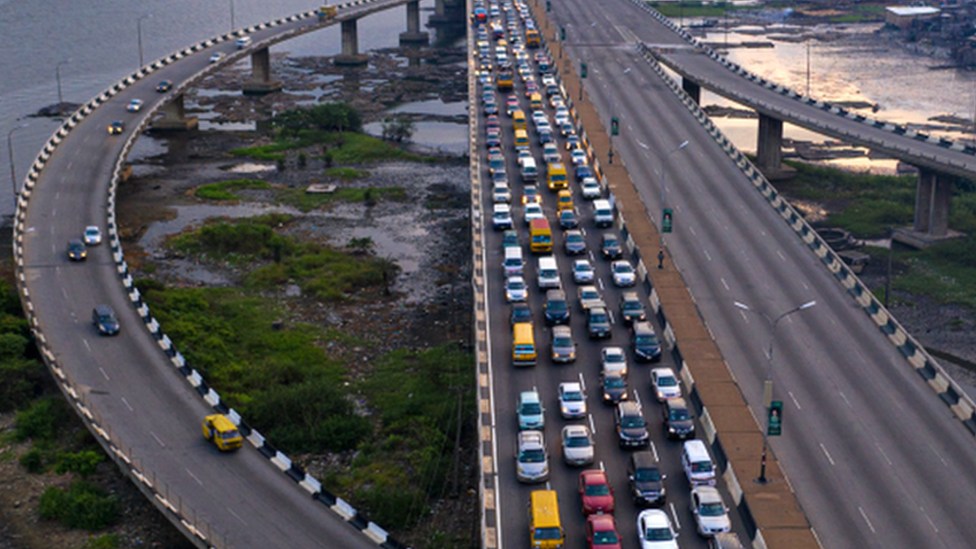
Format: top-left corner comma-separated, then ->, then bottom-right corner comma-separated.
472,3 -> 744,547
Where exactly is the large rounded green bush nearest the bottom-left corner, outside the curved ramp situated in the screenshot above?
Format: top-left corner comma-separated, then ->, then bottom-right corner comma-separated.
39,481 -> 119,531
